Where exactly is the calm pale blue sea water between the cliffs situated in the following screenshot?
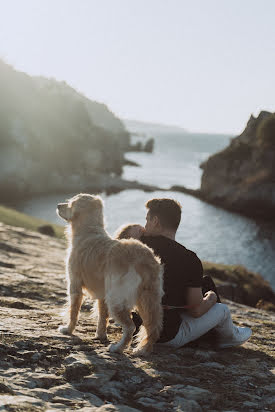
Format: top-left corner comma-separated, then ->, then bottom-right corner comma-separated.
16,128 -> 275,290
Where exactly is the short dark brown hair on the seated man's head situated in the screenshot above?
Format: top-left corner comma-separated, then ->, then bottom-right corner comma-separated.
145,198 -> 181,230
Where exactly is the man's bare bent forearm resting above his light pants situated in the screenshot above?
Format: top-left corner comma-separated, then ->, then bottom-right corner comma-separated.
186,287 -> 217,318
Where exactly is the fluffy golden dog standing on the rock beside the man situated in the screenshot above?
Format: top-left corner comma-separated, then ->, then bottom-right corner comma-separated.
57,194 -> 163,355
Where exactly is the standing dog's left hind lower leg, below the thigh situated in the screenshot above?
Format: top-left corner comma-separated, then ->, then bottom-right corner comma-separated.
109,306 -> 136,353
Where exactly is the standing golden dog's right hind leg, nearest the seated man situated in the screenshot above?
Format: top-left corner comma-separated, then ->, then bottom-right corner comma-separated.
135,258 -> 164,355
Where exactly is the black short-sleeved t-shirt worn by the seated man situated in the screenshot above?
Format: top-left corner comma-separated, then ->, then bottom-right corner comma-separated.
140,236 -> 203,342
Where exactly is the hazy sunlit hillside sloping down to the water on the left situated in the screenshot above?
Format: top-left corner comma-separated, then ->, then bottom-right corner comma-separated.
0,60 -> 130,203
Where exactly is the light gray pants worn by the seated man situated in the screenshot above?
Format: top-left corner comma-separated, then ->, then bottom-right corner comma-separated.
162,303 -> 236,348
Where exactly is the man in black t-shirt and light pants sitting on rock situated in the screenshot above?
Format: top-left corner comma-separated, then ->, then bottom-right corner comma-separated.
137,199 -> 252,348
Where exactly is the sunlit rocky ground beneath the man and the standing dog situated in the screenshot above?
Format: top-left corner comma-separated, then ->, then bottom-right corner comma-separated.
0,223 -> 275,412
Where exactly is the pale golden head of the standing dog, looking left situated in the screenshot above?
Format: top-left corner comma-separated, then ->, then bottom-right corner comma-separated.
56,193 -> 103,223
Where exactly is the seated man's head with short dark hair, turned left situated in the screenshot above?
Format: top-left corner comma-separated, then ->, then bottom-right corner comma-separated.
145,198 -> 181,235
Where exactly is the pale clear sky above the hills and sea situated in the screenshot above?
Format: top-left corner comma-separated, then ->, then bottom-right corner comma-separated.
0,0 -> 275,135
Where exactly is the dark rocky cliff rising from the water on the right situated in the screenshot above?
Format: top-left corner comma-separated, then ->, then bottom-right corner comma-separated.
199,112 -> 275,219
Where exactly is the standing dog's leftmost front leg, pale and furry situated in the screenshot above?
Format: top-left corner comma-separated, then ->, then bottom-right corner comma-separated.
59,279 -> 83,335
